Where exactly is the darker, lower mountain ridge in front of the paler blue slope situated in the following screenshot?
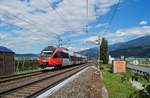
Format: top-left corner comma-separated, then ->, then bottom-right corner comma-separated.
110,45 -> 150,58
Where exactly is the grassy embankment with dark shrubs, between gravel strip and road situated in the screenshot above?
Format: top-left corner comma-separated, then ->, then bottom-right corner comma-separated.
102,65 -> 150,98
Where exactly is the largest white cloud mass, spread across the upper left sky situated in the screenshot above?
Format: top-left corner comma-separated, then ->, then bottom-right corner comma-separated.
0,0 -> 119,52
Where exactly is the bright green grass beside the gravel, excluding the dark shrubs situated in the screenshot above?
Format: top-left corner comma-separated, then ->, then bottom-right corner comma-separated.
102,65 -> 135,98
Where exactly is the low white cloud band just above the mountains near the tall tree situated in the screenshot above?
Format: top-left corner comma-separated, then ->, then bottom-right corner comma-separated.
82,26 -> 150,44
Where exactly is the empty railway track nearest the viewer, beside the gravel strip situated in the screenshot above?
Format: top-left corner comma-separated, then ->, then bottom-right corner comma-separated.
0,65 -> 87,98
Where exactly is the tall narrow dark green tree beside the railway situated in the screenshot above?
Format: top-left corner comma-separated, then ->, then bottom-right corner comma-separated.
100,38 -> 109,64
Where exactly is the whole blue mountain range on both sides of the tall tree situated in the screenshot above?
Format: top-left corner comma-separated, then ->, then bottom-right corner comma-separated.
80,35 -> 150,57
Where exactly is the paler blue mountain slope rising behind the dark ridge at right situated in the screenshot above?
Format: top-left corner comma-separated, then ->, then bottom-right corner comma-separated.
109,35 -> 150,51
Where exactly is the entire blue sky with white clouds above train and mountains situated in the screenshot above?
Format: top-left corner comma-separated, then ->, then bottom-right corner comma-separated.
0,0 -> 150,53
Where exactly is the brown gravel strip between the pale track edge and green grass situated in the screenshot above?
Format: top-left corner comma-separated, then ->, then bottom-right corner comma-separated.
49,66 -> 103,98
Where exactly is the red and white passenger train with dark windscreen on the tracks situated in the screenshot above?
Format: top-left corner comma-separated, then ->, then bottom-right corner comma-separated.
40,46 -> 87,69
